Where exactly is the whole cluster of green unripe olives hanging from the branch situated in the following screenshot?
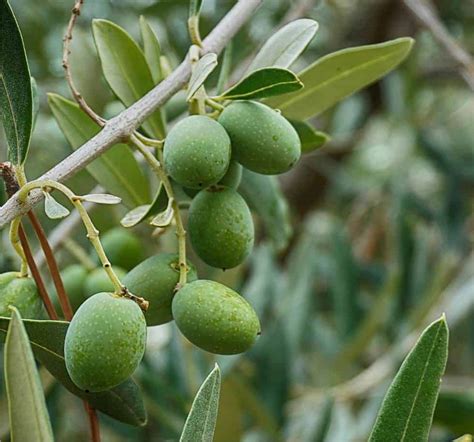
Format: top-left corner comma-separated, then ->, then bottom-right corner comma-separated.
0,101 -> 301,392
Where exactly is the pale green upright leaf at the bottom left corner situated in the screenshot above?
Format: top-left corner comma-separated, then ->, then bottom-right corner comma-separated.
5,308 -> 54,442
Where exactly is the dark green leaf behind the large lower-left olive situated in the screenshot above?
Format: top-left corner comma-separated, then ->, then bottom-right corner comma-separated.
0,317 -> 147,426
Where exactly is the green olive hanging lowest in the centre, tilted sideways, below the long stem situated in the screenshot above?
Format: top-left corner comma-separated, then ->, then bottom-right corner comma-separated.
173,280 -> 260,355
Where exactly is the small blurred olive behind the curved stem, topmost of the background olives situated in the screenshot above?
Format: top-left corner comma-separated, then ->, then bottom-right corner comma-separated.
95,227 -> 145,270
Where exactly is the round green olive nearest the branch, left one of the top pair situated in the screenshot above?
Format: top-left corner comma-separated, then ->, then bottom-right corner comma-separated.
163,115 -> 231,189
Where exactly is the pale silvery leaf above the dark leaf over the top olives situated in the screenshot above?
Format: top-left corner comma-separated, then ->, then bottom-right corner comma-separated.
247,18 -> 319,72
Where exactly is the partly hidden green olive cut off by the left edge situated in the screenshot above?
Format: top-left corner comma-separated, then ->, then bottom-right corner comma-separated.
0,272 -> 43,319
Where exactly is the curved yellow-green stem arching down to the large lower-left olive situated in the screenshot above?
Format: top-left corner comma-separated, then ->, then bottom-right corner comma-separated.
18,180 -> 127,296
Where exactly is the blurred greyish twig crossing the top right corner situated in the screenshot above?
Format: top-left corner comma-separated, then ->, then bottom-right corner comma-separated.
403,0 -> 474,91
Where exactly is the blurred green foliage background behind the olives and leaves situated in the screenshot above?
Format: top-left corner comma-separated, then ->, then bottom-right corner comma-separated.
0,0 -> 474,442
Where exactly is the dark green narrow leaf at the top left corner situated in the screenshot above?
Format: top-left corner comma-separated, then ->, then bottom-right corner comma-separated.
0,0 -> 33,165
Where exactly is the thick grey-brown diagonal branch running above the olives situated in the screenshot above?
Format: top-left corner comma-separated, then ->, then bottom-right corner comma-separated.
0,0 -> 263,227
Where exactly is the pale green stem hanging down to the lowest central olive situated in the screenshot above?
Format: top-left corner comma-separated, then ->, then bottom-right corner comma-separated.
130,135 -> 188,289
